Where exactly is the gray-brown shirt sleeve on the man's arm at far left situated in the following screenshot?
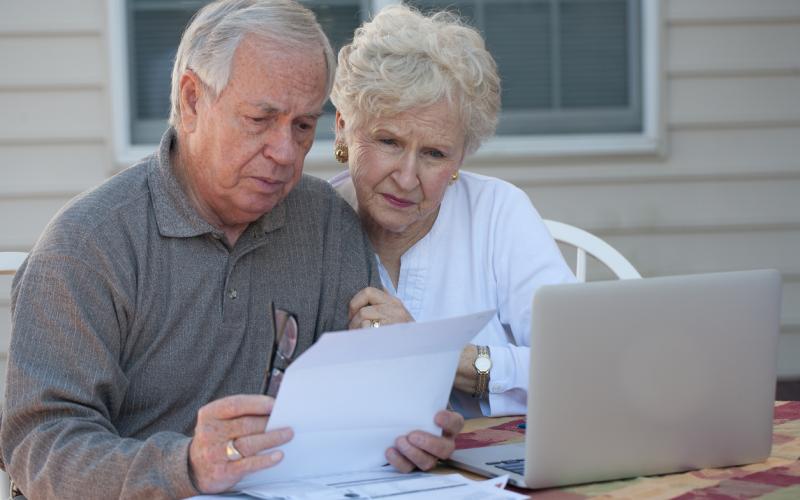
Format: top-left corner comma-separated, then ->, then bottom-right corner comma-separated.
0,251 -> 198,498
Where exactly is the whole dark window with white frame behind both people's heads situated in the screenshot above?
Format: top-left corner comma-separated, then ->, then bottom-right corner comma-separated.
109,0 -> 658,156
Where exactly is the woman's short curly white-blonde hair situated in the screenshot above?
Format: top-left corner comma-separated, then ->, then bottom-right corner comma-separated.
331,5 -> 500,154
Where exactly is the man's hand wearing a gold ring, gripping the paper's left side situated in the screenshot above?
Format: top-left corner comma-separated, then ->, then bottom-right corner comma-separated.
189,395 -> 293,493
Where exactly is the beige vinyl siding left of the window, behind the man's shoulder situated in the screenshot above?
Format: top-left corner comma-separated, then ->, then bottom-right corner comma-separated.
0,0 -> 113,402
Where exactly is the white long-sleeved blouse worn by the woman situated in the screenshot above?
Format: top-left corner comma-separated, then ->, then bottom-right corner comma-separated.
331,170 -> 575,418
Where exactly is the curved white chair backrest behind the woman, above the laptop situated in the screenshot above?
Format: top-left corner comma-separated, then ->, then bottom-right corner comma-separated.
544,220 -> 642,282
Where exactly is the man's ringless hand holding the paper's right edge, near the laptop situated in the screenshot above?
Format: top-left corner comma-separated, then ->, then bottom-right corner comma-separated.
386,410 -> 464,472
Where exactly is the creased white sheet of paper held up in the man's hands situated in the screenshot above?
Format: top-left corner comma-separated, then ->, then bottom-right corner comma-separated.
236,311 -> 495,491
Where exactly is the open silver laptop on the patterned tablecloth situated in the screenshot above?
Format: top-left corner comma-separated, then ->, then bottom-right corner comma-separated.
451,270 -> 781,488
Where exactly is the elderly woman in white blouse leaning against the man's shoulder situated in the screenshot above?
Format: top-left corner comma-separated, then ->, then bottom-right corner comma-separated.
331,6 -> 574,417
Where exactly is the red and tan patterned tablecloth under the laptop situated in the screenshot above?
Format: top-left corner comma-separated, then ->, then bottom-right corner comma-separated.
456,401 -> 800,500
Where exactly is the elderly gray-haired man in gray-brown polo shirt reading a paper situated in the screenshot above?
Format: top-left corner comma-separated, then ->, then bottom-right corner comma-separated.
0,0 -> 463,498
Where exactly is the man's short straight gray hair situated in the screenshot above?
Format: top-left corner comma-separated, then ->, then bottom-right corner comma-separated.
169,0 -> 336,126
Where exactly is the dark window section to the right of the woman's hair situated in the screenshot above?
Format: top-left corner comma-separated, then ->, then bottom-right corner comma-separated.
408,0 -> 642,134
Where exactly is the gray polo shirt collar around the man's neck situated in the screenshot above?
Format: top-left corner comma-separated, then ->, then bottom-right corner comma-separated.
147,127 -> 286,239
